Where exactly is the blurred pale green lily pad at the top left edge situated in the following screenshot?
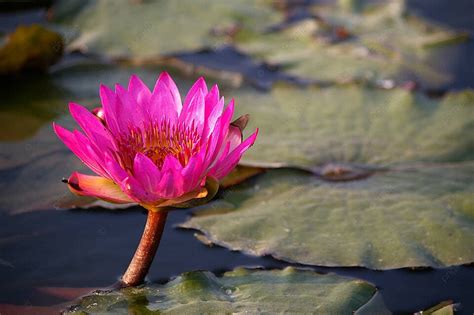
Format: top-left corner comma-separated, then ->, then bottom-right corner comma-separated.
52,0 -> 280,57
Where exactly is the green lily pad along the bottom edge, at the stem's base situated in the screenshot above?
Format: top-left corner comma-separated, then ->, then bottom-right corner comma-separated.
66,267 -> 376,314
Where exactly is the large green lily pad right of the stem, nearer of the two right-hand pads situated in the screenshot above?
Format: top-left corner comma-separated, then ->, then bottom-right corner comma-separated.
182,162 -> 474,269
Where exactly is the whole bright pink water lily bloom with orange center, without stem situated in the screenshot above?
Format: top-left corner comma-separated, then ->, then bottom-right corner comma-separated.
53,72 -> 258,211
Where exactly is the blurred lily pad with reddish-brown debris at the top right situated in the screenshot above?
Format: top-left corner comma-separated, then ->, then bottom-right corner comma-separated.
236,0 -> 467,87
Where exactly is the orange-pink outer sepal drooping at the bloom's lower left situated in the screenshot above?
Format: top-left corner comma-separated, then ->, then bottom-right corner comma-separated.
68,172 -> 133,203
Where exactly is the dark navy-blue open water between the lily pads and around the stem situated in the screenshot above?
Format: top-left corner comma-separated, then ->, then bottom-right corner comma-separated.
0,0 -> 474,314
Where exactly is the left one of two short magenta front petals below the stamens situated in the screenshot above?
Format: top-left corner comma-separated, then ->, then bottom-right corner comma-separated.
133,153 -> 161,193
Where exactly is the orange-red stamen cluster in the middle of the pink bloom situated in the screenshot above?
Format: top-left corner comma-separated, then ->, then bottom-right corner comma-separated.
117,121 -> 201,171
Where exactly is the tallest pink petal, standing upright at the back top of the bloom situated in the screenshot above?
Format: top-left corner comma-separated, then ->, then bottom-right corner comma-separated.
148,72 -> 182,122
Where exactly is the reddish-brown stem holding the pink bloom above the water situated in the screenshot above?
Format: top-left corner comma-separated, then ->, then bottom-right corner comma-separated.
122,210 -> 168,286
